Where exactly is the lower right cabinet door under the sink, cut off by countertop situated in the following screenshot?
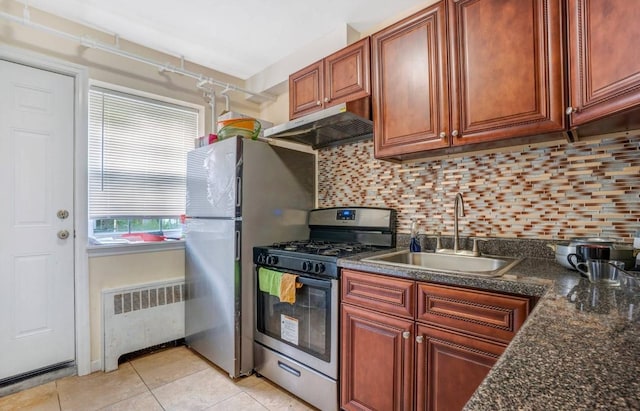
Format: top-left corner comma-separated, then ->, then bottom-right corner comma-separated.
415,324 -> 505,411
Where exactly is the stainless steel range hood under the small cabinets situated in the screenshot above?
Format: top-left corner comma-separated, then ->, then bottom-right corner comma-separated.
264,99 -> 373,149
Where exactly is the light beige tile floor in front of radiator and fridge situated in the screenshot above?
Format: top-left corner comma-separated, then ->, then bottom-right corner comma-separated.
0,347 -> 315,411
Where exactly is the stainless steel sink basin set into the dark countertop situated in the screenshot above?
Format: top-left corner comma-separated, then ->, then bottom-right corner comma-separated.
362,250 -> 522,277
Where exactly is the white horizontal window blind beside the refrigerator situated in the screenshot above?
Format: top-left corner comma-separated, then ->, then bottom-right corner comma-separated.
89,88 -> 198,219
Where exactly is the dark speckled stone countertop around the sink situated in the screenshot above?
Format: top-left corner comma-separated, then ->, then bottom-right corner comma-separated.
338,250 -> 640,411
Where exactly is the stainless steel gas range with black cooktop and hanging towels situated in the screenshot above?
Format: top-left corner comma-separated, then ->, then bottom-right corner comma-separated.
253,207 -> 396,410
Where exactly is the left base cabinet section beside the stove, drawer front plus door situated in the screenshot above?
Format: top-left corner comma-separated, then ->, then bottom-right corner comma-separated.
340,270 -> 415,410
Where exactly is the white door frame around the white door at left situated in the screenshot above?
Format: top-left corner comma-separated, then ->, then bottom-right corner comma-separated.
0,45 -> 91,375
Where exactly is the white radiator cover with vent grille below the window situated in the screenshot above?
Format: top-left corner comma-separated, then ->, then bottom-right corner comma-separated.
102,279 -> 185,371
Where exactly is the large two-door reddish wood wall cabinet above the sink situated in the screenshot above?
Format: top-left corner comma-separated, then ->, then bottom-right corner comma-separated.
371,0 -> 566,160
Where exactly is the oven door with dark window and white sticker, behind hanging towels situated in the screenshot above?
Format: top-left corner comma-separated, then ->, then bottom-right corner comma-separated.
255,267 -> 338,379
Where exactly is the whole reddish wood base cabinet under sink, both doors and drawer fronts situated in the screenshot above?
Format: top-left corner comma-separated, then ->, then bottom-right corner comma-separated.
341,270 -> 533,410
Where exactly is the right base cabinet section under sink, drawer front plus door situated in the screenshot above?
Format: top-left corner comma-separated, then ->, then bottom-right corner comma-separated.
416,282 -> 532,410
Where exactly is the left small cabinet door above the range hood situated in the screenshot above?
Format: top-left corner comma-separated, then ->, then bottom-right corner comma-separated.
289,60 -> 324,120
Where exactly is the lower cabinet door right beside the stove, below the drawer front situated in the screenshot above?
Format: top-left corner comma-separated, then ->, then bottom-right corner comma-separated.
340,304 -> 414,411
